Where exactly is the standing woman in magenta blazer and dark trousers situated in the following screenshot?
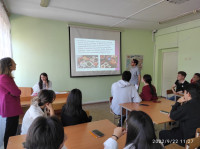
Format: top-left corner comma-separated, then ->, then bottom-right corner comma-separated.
0,57 -> 23,149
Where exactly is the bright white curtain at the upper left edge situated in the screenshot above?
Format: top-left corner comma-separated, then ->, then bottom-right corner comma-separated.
0,0 -> 12,59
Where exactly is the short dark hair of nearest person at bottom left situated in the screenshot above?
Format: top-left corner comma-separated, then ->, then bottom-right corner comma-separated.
25,116 -> 64,149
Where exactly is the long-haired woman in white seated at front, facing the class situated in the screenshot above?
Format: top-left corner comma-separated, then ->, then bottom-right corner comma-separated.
32,72 -> 52,96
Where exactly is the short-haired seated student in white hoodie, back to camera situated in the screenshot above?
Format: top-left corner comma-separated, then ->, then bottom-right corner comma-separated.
110,71 -> 142,126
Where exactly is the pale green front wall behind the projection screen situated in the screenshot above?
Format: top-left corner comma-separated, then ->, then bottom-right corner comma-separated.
10,14 -> 153,103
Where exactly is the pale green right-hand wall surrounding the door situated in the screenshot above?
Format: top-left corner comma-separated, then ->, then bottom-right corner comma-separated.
155,20 -> 200,95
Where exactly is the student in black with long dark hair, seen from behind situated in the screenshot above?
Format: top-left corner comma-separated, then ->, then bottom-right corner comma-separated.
61,89 -> 92,126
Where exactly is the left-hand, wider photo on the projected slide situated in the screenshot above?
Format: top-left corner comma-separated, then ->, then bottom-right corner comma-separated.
77,55 -> 98,68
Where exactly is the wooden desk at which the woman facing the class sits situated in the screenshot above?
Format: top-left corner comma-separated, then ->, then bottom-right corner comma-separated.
20,93 -> 69,110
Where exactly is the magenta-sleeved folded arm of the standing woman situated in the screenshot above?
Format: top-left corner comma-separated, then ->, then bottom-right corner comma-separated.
2,78 -> 21,97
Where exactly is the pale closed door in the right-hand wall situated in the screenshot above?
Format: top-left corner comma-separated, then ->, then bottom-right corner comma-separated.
162,51 -> 178,97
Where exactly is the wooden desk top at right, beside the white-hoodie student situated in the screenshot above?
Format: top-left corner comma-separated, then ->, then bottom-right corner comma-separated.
120,98 -> 175,124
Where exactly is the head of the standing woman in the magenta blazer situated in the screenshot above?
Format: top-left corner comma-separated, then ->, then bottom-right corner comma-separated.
0,57 -> 16,77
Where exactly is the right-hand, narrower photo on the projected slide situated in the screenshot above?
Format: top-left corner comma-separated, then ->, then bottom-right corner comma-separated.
100,55 -> 118,68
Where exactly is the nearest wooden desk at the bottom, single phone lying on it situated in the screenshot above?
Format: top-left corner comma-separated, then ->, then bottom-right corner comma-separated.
7,120 -> 126,149
